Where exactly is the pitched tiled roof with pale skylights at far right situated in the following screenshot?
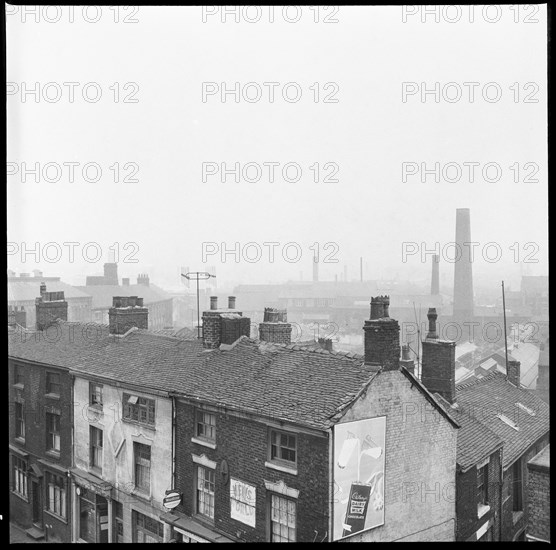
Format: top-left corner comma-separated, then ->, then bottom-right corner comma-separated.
456,372 -> 550,468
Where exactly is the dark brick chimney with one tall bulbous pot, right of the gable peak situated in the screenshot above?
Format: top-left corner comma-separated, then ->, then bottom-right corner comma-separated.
421,308 -> 456,404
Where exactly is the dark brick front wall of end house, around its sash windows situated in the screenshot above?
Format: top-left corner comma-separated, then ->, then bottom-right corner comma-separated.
176,401 -> 328,542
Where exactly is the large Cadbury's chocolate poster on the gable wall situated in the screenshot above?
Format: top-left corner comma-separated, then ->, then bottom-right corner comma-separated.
333,416 -> 386,540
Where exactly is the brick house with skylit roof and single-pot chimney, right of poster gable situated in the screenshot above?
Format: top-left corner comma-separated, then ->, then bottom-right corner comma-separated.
422,308 -> 550,541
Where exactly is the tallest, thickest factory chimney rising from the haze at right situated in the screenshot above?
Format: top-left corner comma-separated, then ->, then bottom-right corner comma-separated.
453,208 -> 473,320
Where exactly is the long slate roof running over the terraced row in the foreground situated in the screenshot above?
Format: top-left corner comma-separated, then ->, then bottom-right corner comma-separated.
9,321 -> 384,429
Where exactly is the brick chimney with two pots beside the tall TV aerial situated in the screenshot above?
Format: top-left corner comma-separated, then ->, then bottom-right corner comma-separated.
203,296 -> 251,349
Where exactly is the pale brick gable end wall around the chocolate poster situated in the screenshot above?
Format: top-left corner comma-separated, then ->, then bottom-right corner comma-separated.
342,371 -> 457,542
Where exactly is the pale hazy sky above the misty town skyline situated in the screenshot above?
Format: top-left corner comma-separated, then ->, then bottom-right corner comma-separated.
7,6 -> 548,292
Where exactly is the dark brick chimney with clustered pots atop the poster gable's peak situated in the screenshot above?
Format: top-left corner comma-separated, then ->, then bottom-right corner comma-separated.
363,296 -> 400,370
